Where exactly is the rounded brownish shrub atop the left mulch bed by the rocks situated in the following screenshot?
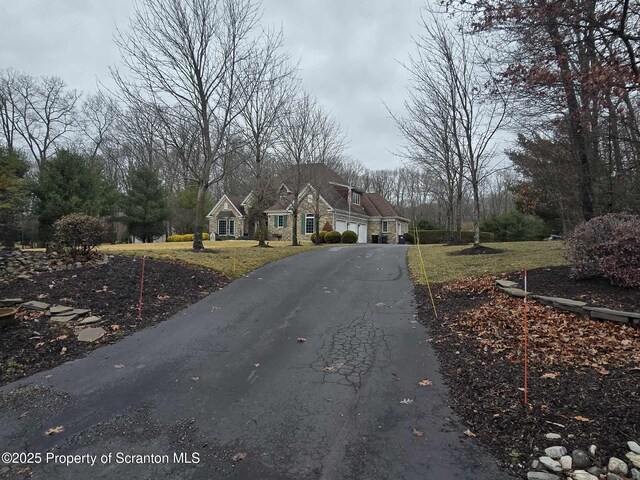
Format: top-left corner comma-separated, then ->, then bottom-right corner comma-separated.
53,213 -> 108,255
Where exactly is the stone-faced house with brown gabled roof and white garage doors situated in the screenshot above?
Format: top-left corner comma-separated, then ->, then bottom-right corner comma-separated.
207,164 -> 409,243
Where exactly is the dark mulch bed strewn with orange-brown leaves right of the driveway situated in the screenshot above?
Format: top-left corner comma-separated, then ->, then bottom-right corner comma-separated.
416,267 -> 640,478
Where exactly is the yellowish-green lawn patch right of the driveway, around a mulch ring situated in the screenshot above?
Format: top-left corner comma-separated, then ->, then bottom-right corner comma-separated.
407,241 -> 567,284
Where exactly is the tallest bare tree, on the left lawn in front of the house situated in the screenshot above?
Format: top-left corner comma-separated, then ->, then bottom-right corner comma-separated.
112,0 -> 259,250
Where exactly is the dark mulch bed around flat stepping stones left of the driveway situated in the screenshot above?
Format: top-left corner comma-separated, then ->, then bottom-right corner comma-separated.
0,256 -> 229,385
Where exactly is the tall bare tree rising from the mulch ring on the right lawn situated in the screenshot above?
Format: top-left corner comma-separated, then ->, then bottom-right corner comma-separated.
397,13 -> 507,245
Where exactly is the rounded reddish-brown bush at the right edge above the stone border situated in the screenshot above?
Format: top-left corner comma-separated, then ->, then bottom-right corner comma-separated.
567,213 -> 640,287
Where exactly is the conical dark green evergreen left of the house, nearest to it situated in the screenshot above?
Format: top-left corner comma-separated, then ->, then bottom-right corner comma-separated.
124,165 -> 169,243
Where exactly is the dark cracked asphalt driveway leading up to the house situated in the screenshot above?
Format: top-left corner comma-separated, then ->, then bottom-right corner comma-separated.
0,245 -> 512,480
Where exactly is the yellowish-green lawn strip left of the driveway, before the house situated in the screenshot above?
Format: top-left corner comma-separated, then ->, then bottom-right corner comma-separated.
99,240 -> 330,279
